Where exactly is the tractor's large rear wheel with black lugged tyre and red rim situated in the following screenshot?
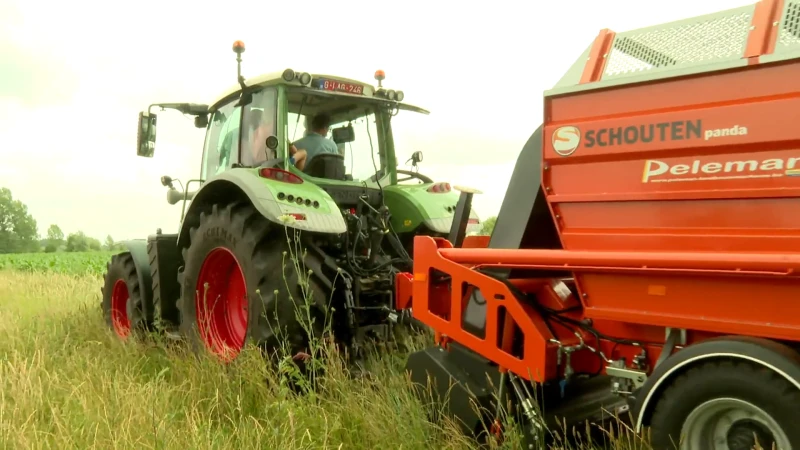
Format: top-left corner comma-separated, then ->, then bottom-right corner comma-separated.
178,203 -> 326,373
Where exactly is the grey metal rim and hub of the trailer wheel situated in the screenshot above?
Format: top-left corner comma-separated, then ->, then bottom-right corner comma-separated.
681,398 -> 791,450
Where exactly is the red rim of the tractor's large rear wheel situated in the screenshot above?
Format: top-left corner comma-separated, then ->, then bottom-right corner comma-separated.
196,247 -> 248,360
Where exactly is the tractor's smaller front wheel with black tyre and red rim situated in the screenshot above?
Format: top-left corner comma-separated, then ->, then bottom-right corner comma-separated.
100,252 -> 150,340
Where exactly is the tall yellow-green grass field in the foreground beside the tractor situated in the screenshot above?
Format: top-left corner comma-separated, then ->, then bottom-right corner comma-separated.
0,254 -> 645,449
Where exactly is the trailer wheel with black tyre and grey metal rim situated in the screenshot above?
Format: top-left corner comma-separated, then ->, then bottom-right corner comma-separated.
650,360 -> 800,450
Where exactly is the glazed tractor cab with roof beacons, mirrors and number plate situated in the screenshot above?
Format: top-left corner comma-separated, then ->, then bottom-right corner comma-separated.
138,42 -> 438,187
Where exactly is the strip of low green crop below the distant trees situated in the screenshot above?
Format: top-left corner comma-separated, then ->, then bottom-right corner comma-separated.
0,252 -> 114,275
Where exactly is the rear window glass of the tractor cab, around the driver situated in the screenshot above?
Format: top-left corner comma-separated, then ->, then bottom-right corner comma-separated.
288,96 -> 386,181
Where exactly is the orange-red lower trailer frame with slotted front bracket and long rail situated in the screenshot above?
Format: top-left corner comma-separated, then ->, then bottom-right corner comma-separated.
407,236 -> 800,382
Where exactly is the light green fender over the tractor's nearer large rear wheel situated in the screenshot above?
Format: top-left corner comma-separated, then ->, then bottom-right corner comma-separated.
178,168 -> 347,247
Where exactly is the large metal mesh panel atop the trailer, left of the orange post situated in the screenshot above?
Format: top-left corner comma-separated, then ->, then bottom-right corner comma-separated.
603,7 -> 752,78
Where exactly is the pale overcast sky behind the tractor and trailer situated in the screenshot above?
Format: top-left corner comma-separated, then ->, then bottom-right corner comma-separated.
0,0 -> 755,240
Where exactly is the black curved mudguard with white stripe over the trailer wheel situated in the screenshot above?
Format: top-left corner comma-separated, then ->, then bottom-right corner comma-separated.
632,336 -> 800,433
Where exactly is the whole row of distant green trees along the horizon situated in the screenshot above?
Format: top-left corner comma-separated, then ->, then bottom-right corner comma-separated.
0,187 -> 123,254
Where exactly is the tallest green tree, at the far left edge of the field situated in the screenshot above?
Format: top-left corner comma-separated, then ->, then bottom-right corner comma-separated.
0,188 -> 41,253
